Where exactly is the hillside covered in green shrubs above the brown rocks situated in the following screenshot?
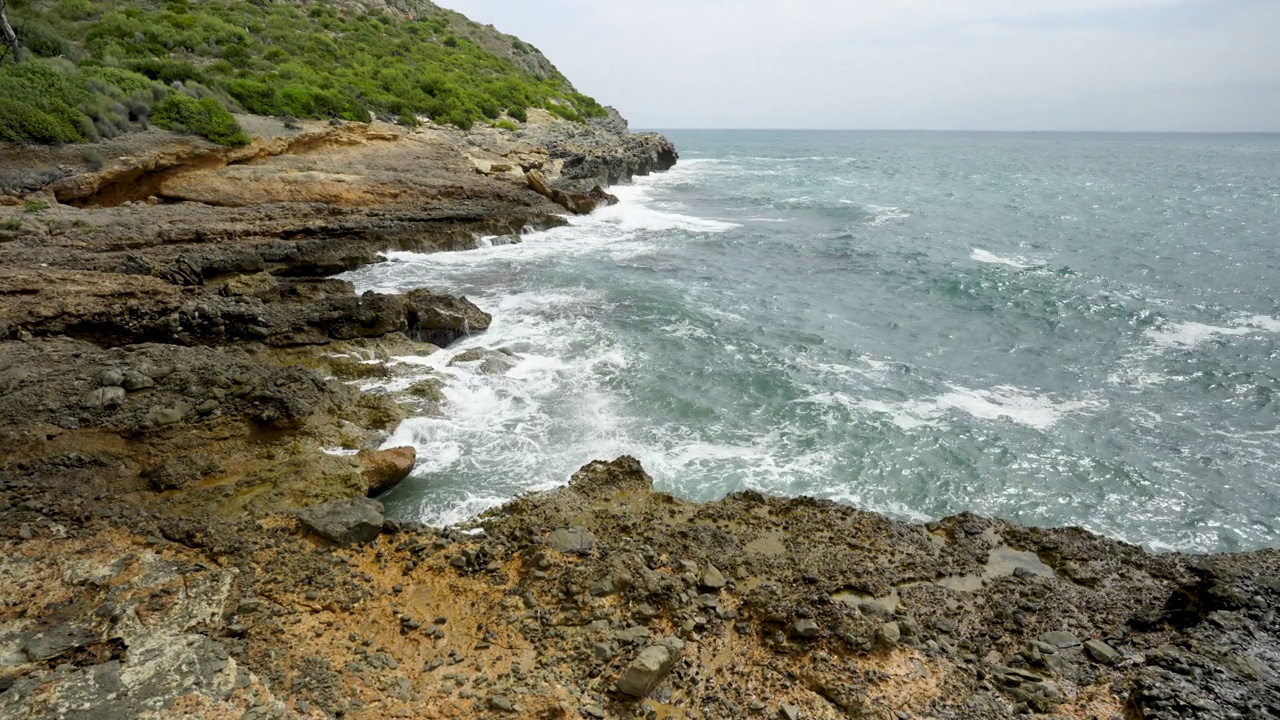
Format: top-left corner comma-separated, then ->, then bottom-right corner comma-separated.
0,0 -> 605,145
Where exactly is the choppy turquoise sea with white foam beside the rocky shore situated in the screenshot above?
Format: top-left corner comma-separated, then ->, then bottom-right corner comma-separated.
351,131 -> 1280,551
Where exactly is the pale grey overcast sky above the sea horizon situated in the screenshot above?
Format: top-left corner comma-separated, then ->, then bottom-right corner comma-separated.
440,0 -> 1280,131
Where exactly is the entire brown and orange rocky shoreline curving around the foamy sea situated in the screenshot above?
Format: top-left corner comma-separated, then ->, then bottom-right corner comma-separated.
0,114 -> 1280,720
